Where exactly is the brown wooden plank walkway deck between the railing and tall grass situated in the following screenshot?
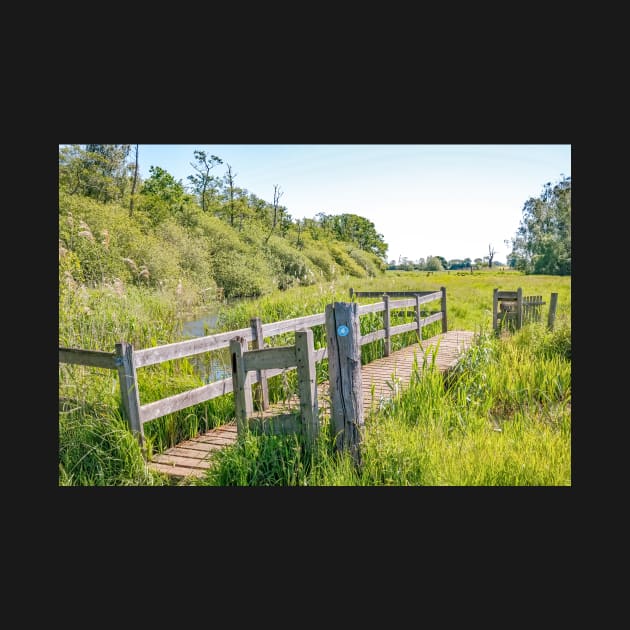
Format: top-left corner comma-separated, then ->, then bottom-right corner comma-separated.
148,330 -> 475,480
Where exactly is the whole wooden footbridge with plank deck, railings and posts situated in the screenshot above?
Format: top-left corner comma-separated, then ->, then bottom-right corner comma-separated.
59,287 -> 555,478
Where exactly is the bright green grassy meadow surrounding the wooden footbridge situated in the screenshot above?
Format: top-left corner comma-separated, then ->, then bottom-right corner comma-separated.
59,270 -> 571,486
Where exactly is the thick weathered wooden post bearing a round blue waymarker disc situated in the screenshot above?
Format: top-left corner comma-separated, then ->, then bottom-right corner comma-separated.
325,302 -> 363,464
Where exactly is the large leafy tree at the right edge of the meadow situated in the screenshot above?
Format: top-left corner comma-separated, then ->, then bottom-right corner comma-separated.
508,175 -> 571,275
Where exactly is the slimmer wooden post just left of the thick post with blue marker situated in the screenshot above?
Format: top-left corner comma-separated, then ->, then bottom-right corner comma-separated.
295,328 -> 319,447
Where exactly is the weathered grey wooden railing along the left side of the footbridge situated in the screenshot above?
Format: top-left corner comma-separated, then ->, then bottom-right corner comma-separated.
59,288 -> 446,454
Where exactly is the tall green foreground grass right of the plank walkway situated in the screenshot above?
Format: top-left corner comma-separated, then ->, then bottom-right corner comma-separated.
197,320 -> 571,486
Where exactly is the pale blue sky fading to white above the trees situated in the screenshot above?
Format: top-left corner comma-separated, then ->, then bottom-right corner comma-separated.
132,144 -> 571,262
